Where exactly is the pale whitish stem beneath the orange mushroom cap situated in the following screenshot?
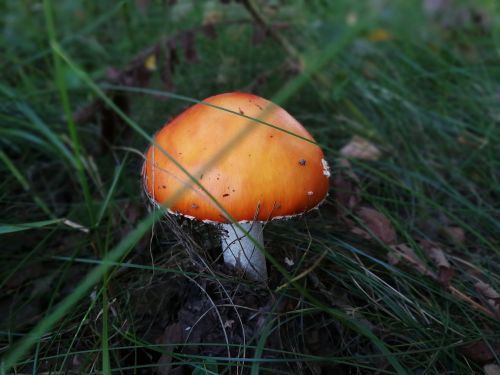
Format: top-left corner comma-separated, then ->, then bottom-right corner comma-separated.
221,222 -> 267,281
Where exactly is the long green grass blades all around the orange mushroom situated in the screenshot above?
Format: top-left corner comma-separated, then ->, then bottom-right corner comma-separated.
0,0 -> 500,374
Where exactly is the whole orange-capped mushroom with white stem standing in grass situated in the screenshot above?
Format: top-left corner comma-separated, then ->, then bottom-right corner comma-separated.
142,92 -> 330,281
